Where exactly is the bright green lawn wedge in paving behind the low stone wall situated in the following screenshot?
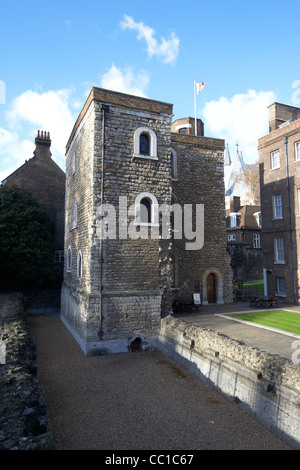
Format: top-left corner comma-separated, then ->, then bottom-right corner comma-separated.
230,310 -> 300,335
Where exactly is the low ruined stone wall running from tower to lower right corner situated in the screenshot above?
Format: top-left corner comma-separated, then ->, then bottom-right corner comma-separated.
159,316 -> 300,448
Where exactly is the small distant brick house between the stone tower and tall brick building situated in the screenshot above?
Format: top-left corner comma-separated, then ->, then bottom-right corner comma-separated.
226,196 -> 263,281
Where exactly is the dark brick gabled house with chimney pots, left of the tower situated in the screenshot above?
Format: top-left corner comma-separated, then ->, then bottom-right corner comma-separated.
2,131 -> 66,263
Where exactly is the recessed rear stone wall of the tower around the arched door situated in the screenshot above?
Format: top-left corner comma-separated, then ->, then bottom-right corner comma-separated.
172,134 -> 232,303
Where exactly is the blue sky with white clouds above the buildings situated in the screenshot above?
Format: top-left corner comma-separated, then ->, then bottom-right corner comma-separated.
0,0 -> 300,180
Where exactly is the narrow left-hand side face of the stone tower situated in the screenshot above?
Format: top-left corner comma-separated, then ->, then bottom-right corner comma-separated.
61,103 -> 96,344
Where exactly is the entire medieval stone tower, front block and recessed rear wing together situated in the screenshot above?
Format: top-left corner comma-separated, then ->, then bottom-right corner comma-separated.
61,88 -> 232,354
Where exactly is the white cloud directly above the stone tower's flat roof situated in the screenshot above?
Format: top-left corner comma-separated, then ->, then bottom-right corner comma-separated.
101,64 -> 149,97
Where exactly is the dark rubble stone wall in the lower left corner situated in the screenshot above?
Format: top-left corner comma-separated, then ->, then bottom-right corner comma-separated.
0,293 -> 53,450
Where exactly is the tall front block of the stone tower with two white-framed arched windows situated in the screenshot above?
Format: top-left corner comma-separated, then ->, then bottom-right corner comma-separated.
62,88 -> 172,353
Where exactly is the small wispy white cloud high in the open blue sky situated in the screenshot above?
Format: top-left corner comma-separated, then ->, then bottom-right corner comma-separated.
121,15 -> 179,64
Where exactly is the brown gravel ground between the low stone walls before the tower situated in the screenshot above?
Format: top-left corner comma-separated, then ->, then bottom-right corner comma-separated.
28,315 -> 290,450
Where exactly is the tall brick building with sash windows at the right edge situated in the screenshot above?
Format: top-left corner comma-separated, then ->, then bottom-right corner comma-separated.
258,103 -> 300,304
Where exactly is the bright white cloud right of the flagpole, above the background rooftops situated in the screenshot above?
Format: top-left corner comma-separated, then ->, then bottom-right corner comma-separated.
203,90 -> 276,163
